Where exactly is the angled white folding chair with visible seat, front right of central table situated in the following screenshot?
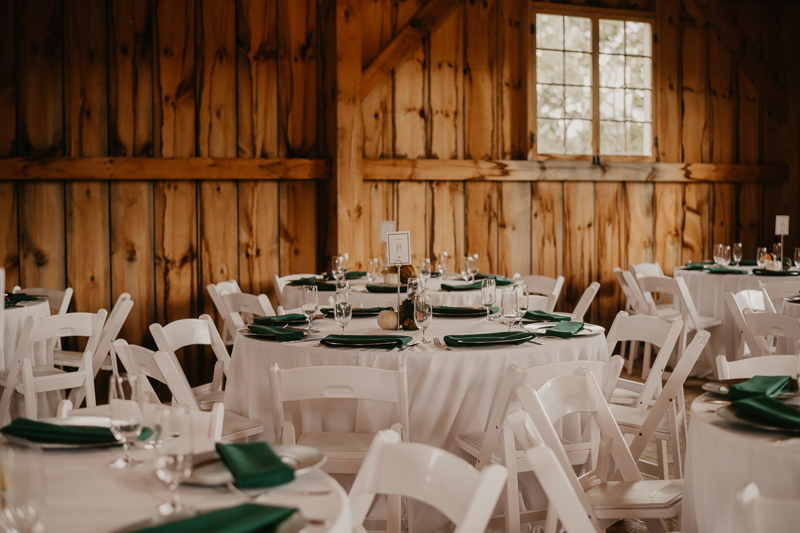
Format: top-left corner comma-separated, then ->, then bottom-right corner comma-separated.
517,372 -> 683,532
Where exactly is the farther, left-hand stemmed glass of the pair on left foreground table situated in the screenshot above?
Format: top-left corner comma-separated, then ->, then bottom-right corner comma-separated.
108,374 -> 144,468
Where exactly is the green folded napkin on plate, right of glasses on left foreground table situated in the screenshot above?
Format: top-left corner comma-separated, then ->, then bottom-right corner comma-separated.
217,442 -> 294,489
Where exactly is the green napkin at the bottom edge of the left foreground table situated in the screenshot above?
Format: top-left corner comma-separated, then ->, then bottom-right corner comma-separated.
130,503 -> 297,533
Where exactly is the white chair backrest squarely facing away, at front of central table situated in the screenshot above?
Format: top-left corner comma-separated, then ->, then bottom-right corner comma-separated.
270,363 -> 411,441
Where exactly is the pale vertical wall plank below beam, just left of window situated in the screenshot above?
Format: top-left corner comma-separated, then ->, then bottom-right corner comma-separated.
497,181 -> 532,276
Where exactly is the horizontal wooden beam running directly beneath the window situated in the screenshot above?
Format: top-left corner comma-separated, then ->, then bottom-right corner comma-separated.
364,159 -> 789,183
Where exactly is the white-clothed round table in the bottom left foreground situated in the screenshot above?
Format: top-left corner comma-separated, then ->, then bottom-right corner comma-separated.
32,439 -> 352,533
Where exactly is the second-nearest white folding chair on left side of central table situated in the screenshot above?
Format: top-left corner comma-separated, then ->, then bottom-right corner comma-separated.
150,315 -> 231,409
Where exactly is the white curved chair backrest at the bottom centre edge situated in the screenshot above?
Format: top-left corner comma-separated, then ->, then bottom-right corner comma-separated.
350,430 -> 506,533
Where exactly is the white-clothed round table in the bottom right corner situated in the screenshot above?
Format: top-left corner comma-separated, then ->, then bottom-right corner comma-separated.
681,394 -> 800,533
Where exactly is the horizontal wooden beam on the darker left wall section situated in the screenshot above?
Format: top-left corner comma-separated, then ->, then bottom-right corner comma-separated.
0,157 -> 331,181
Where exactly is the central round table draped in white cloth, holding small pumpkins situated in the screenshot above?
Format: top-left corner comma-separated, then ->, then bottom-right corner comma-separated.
224,310 -> 608,451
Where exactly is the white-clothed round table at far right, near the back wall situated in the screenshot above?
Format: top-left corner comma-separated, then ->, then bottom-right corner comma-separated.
674,266 -> 800,359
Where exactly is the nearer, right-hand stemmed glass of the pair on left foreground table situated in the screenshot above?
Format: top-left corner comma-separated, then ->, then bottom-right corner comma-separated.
156,407 -> 194,515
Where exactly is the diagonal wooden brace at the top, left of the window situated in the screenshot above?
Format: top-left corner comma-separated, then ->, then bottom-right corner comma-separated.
361,0 -> 461,100
